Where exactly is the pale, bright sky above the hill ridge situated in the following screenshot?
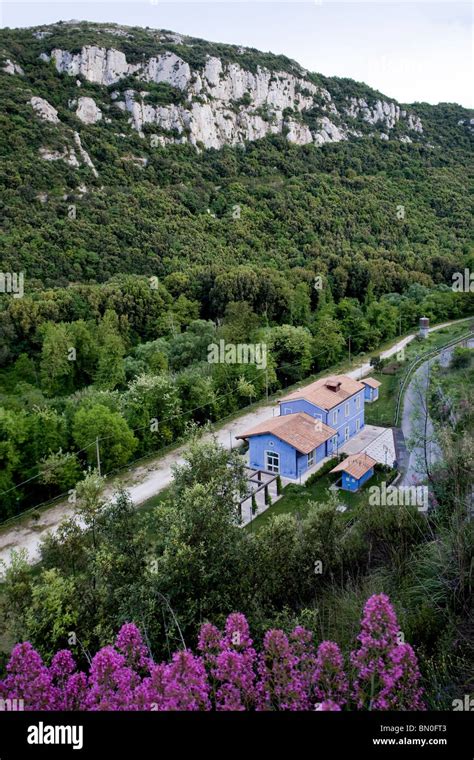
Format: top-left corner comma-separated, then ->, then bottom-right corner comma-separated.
0,0 -> 474,107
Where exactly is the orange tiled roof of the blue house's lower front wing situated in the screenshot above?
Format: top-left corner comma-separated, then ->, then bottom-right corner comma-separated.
236,412 -> 336,454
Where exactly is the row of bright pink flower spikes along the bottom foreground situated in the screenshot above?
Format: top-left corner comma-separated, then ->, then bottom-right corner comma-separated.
0,594 -> 423,711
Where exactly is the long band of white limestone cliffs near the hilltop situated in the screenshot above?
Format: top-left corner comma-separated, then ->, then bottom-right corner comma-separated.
52,45 -> 423,148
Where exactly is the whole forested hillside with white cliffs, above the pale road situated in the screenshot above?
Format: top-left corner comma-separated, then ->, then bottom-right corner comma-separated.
0,22 -> 472,518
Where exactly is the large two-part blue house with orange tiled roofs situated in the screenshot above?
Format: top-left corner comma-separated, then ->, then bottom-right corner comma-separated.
237,375 -> 374,479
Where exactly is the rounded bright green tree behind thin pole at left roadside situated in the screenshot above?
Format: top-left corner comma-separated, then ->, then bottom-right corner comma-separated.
72,404 -> 138,473
